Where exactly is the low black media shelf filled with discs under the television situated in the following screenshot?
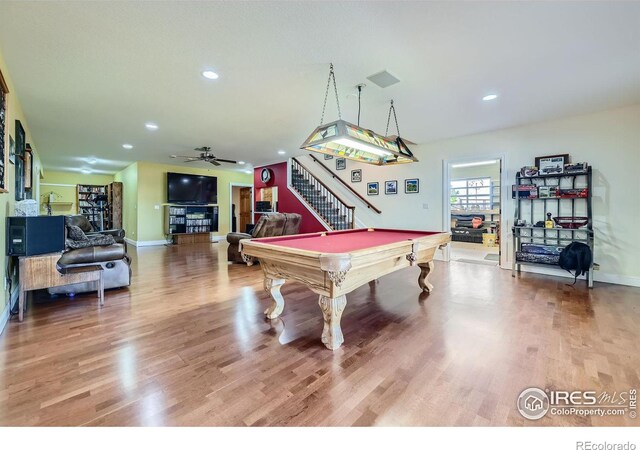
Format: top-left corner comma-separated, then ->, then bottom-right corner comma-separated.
164,205 -> 218,235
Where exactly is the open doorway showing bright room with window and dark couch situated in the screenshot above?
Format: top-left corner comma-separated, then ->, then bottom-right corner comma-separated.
443,157 -> 504,267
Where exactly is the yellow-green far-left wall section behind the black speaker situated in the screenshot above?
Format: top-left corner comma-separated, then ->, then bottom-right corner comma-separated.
40,170 -> 114,215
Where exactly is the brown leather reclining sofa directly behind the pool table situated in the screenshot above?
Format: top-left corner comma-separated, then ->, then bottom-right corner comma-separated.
227,213 -> 302,263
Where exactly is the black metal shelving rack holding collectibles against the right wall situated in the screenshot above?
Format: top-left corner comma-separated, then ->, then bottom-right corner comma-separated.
512,164 -> 594,287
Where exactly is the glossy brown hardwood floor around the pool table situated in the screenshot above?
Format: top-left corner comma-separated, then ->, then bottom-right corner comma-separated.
0,244 -> 640,426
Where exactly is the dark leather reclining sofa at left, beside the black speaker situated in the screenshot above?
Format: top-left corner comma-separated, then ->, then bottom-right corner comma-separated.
49,215 -> 131,294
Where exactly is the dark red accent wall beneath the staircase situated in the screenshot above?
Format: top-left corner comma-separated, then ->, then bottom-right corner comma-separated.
253,162 -> 326,233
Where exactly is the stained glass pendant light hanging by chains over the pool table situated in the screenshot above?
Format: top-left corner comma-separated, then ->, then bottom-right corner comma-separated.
300,64 -> 418,166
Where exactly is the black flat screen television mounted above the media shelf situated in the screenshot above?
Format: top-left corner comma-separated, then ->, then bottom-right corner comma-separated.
167,172 -> 218,205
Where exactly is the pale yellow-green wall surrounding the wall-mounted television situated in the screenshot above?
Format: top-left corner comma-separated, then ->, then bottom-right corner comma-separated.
115,161 -> 253,241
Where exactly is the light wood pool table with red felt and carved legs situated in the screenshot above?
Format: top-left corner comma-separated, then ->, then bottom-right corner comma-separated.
240,228 -> 451,350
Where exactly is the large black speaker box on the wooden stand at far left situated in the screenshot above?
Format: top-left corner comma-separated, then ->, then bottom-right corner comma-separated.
6,216 -> 65,256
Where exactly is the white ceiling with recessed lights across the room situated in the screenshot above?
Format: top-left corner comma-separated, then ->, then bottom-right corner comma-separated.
0,1 -> 640,172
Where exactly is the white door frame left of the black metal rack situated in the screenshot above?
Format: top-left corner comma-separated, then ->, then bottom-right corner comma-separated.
442,153 -> 510,269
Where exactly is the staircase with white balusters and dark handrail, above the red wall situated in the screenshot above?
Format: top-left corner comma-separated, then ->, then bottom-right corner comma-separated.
291,158 -> 356,230
